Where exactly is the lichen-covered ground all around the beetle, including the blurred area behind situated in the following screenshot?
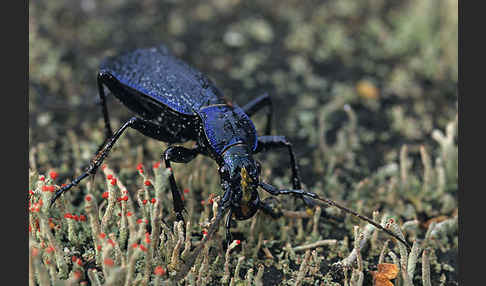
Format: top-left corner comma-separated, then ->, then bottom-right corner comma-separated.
29,0 -> 459,285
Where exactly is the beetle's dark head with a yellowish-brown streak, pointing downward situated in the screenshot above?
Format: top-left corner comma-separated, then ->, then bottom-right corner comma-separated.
219,145 -> 260,220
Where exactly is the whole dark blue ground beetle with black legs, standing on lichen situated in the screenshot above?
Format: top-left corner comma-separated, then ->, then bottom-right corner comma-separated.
51,45 -> 407,251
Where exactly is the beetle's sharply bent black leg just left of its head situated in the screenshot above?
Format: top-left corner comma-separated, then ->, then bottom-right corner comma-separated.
163,146 -> 200,220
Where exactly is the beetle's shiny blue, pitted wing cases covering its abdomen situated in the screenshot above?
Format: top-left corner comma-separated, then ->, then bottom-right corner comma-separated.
100,45 -> 224,115
